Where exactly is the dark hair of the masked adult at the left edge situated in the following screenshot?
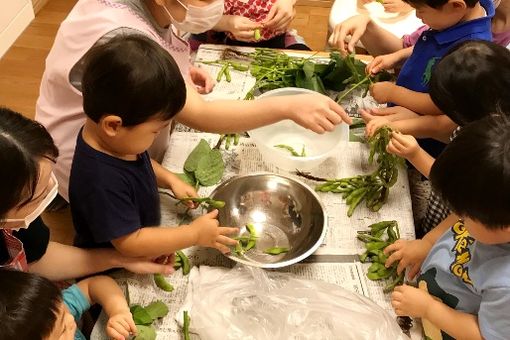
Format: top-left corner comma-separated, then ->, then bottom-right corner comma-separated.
0,107 -> 58,218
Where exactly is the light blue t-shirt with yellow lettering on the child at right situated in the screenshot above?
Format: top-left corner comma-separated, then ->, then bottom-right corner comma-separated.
418,221 -> 510,340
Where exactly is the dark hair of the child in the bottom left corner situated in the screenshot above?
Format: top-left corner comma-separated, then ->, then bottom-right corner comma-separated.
0,270 -> 63,340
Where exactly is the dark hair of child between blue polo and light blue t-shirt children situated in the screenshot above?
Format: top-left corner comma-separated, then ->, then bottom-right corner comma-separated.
429,41 -> 510,126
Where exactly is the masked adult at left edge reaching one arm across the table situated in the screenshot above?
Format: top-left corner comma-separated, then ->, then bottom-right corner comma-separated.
0,108 -> 173,281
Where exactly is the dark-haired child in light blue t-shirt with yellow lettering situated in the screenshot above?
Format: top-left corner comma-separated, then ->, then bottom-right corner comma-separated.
386,112 -> 510,339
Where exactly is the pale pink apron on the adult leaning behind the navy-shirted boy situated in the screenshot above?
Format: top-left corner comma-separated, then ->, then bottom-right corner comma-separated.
35,0 -> 190,201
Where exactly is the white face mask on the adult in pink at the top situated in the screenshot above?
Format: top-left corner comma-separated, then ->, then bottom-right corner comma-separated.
163,0 -> 224,34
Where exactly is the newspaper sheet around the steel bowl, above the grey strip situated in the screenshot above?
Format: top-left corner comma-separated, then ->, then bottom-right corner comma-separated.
161,132 -> 415,255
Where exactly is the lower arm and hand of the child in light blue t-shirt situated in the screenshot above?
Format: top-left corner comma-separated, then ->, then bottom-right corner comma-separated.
391,285 -> 482,340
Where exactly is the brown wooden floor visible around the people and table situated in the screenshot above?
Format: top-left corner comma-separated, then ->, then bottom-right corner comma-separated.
0,0 -> 330,244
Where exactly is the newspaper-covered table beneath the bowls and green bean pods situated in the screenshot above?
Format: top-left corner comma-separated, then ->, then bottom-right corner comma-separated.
92,47 -> 420,340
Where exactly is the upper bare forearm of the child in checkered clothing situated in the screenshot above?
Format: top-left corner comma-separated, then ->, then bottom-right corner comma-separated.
392,115 -> 458,143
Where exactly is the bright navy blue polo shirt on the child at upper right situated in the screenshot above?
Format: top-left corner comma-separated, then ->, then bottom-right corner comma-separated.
397,0 -> 494,92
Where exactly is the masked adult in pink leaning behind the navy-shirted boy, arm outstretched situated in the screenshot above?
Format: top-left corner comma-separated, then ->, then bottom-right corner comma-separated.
36,0 -> 351,200
